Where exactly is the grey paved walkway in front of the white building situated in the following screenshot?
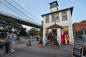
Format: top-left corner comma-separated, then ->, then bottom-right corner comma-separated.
1,41 -> 72,57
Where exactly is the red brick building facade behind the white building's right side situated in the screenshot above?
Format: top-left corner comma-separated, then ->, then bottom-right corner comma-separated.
73,20 -> 86,33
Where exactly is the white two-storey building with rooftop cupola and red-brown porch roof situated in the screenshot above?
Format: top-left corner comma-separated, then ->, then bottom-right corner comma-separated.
42,1 -> 74,44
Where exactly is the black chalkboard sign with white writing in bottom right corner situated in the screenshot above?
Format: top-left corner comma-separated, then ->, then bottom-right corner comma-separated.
73,44 -> 83,57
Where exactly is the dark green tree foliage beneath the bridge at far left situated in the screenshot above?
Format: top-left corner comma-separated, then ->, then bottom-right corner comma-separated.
0,16 -> 22,31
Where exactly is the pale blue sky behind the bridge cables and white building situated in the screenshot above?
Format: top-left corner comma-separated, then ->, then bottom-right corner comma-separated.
0,0 -> 86,29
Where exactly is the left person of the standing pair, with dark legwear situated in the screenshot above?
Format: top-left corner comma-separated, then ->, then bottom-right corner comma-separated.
5,32 -> 12,53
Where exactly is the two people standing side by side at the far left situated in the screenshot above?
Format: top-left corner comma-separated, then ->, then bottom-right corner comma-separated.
5,32 -> 17,53
